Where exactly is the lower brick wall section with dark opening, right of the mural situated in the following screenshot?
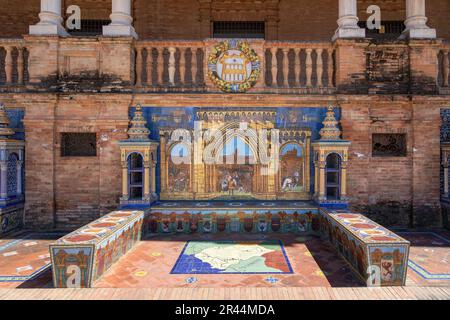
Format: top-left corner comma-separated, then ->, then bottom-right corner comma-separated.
341,97 -> 440,227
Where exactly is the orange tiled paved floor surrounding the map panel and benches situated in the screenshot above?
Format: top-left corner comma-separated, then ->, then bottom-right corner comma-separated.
0,232 -> 450,299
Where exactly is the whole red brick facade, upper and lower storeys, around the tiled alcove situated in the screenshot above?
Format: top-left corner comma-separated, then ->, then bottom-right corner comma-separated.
0,0 -> 450,228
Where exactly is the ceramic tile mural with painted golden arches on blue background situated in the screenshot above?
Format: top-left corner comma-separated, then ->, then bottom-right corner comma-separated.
135,106 -> 340,200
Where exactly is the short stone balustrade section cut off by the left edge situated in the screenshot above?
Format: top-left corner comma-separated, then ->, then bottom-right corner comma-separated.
0,39 -> 28,86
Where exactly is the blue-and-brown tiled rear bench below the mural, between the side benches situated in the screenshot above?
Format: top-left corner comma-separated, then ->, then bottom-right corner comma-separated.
145,201 -> 320,234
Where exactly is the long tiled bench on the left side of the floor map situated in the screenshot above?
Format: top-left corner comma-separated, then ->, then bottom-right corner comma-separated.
50,211 -> 144,288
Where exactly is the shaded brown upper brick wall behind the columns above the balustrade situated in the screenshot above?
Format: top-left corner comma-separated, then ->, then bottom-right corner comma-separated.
0,0 -> 450,40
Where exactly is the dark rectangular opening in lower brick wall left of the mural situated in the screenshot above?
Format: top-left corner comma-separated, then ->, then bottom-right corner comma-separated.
61,133 -> 97,157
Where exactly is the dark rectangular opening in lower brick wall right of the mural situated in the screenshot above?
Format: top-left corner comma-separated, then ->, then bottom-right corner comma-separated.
372,133 -> 407,157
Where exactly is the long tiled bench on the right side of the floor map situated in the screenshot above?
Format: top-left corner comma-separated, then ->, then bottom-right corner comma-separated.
320,210 -> 410,286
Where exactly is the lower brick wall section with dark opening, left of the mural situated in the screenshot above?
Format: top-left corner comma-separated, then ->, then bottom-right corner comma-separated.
14,94 -> 131,229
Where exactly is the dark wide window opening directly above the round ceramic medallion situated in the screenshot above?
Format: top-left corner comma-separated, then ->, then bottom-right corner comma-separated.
213,21 -> 266,39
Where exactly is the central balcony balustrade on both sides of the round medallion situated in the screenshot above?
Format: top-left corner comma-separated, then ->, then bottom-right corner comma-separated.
136,40 -> 335,93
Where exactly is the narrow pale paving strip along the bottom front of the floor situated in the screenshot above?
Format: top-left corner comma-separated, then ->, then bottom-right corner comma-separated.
0,287 -> 450,300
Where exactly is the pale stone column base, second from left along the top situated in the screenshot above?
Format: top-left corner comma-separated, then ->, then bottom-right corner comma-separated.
103,0 -> 138,39
